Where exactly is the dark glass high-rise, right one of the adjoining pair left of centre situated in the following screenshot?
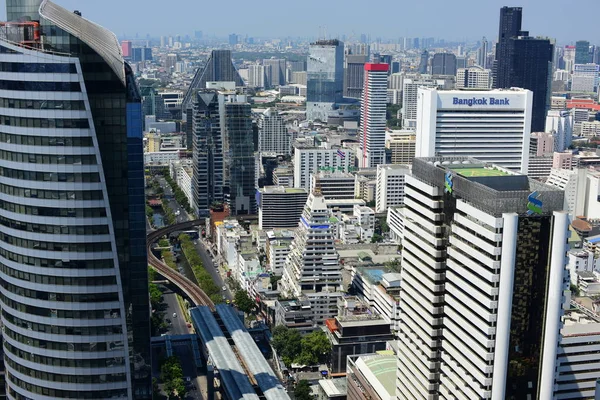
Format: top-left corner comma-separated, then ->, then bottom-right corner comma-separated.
222,96 -> 256,215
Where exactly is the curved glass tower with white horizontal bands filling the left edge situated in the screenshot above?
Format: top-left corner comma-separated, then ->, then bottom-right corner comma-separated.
0,1 -> 152,399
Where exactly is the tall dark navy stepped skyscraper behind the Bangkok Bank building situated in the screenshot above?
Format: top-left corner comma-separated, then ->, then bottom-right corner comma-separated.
495,7 -> 554,132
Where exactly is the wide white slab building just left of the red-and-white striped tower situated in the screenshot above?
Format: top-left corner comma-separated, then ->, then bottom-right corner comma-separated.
294,144 -> 354,190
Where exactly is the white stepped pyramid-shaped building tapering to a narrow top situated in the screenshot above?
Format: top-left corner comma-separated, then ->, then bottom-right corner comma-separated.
281,189 -> 342,324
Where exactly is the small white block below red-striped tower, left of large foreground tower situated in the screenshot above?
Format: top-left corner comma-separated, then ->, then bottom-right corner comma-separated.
375,164 -> 410,213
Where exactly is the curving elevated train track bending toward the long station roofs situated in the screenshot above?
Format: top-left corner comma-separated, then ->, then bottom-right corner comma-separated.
146,219 -> 215,310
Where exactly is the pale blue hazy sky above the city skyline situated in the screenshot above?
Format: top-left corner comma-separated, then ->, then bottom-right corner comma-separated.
0,0 -> 600,44
